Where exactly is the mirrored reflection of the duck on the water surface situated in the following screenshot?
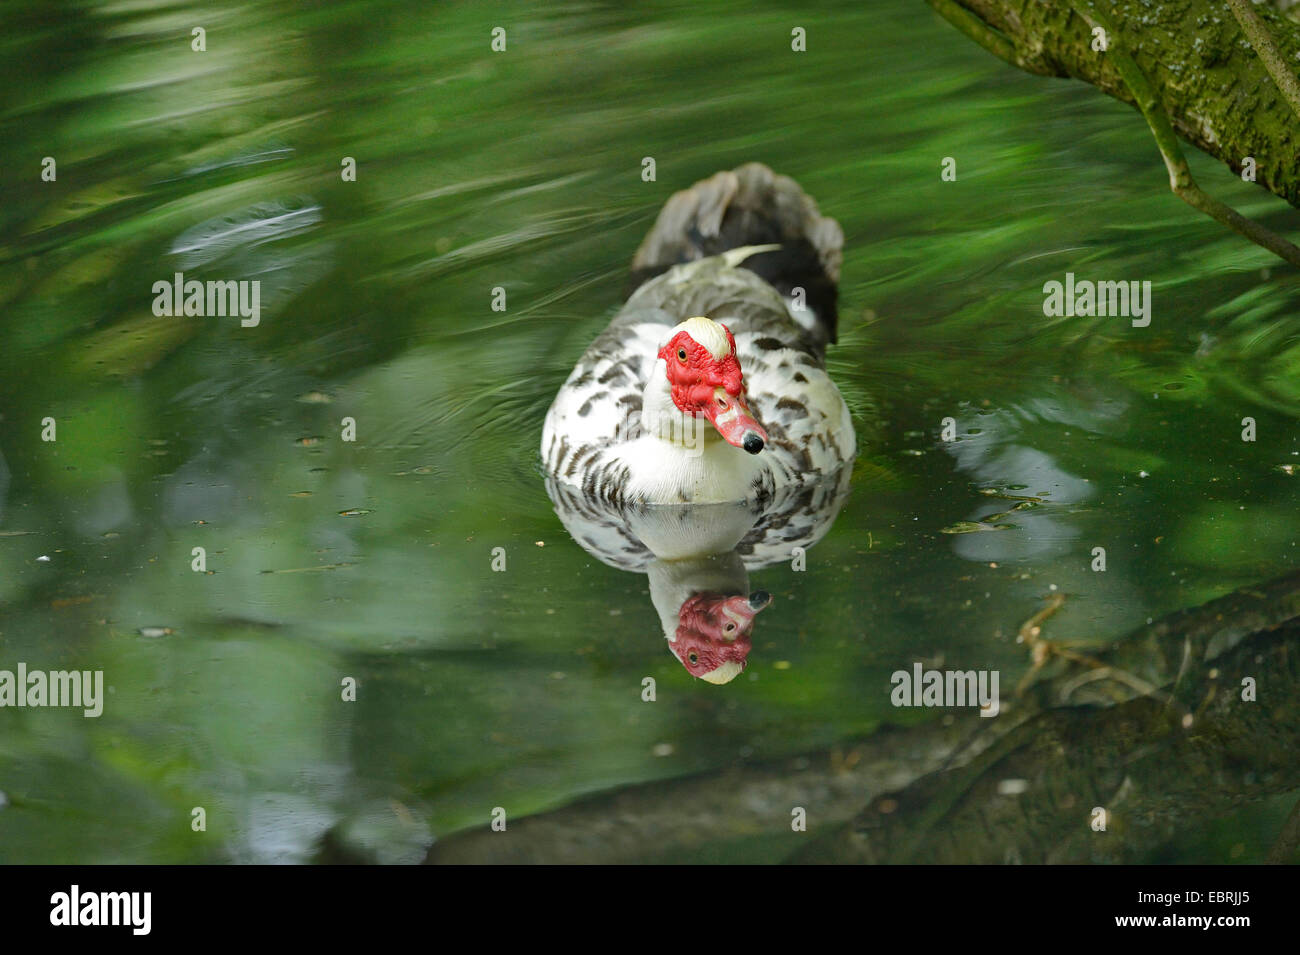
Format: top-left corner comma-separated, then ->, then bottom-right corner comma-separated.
546,468 -> 850,683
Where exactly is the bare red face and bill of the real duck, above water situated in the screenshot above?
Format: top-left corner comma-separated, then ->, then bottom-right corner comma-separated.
659,325 -> 767,455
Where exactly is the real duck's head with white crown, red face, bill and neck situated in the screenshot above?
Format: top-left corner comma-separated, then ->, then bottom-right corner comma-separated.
642,317 -> 767,455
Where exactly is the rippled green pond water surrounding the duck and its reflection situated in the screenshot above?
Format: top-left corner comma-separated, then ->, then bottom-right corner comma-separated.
0,0 -> 1300,863
